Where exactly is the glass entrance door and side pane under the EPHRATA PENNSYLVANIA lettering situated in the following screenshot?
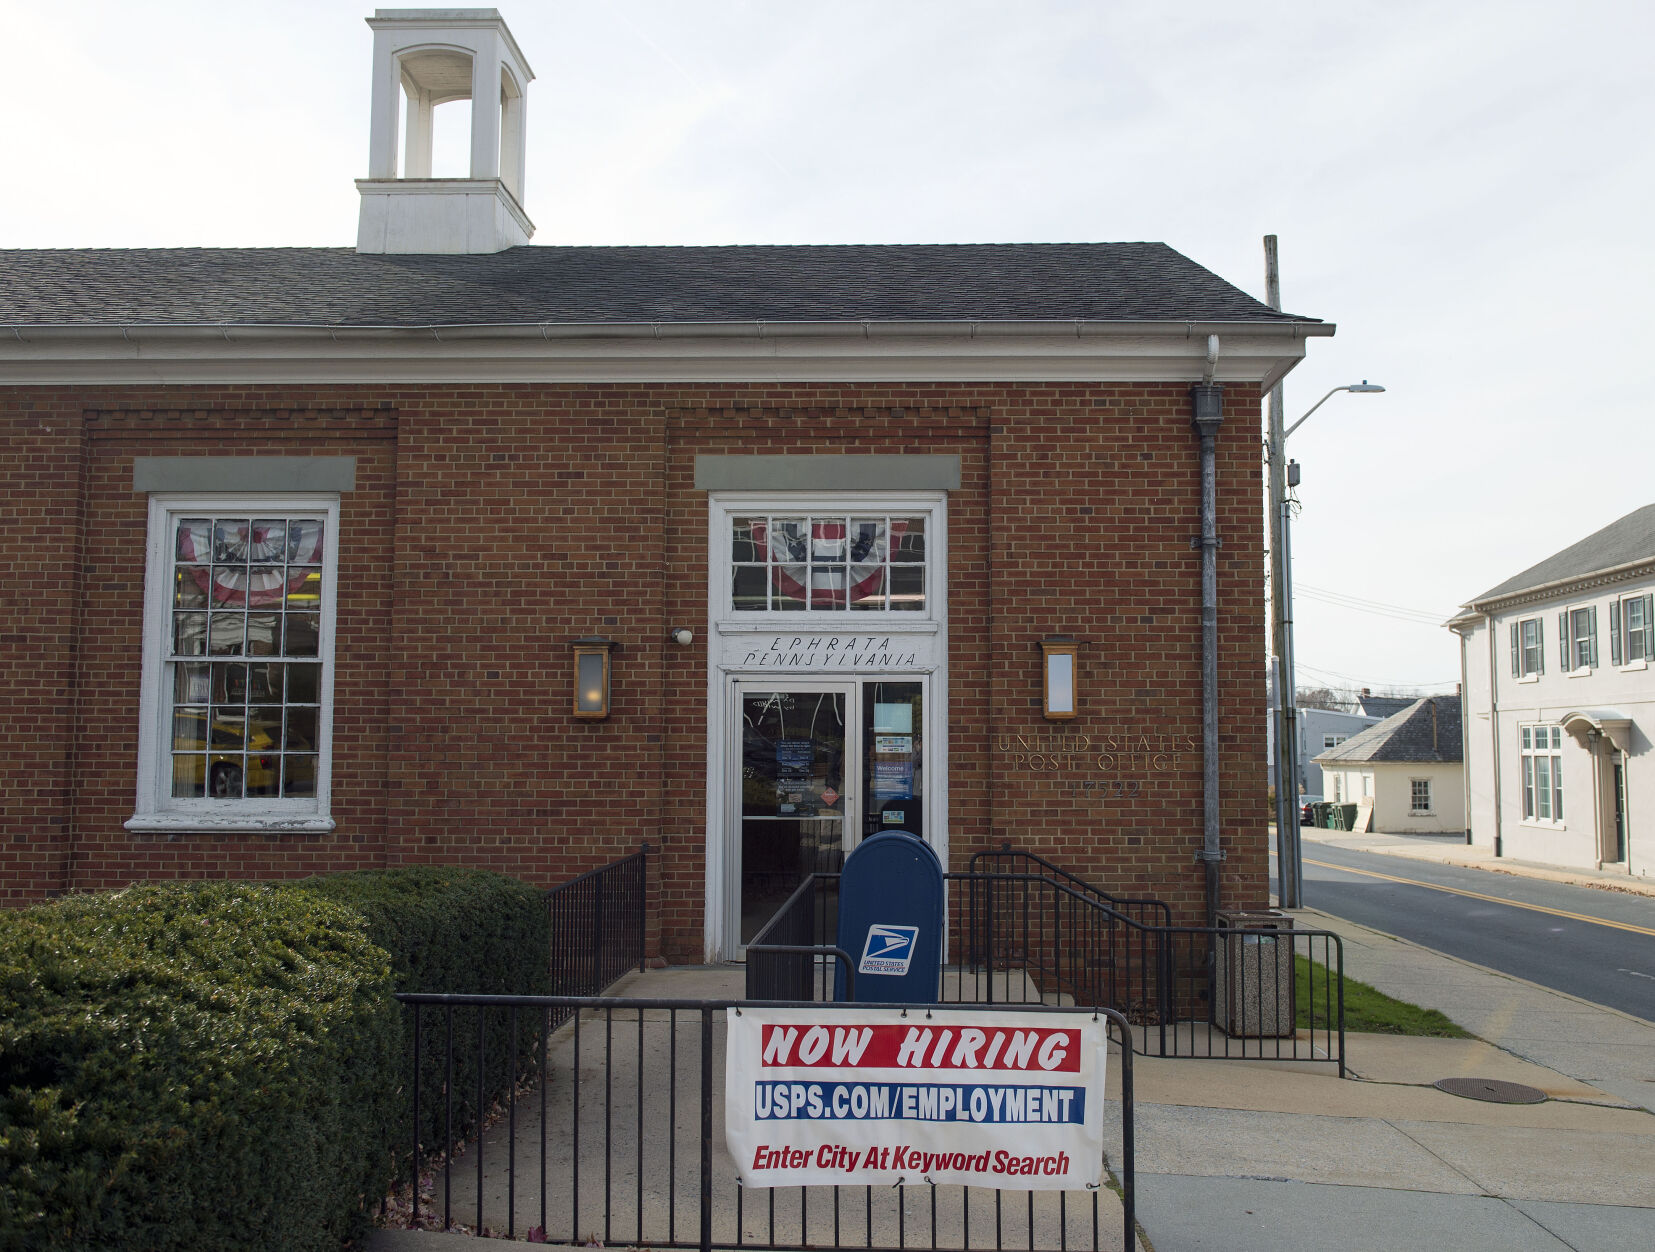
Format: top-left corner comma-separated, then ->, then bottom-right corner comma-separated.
732,679 -> 927,946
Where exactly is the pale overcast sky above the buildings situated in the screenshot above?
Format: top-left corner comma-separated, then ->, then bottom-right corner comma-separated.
0,0 -> 1655,691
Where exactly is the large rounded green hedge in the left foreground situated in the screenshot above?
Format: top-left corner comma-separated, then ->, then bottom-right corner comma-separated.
0,883 -> 401,1250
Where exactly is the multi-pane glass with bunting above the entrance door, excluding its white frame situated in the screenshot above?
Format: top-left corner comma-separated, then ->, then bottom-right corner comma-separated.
730,513 -> 927,613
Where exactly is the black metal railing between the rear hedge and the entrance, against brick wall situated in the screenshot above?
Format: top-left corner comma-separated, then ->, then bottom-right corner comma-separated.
546,843 -> 649,1000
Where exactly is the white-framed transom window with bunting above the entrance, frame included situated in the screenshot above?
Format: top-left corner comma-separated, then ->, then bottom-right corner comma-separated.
712,492 -> 943,631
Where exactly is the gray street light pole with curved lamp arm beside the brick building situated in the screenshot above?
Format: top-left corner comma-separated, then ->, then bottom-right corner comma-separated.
1266,375 -> 1384,909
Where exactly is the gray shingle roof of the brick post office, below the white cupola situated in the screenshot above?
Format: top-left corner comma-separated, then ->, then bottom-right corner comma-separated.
0,243 -> 1317,328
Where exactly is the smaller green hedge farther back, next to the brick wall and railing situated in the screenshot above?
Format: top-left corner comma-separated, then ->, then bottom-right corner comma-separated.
298,866 -> 551,1161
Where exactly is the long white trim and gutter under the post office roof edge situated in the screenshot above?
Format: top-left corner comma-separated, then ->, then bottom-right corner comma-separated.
0,321 -> 1334,389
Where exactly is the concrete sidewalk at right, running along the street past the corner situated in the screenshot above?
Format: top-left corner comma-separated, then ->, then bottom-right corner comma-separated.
367,867 -> 1655,1252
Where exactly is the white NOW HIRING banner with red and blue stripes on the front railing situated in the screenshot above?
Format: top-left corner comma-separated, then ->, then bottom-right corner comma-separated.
725,1005 -> 1107,1191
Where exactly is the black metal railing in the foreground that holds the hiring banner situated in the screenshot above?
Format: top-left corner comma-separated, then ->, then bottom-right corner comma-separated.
397,994 -> 1135,1252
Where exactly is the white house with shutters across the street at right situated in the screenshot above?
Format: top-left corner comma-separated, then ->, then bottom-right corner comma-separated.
1448,505 -> 1655,878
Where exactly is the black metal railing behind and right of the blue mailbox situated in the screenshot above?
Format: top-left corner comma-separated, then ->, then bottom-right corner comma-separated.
746,873 -> 1346,1076
